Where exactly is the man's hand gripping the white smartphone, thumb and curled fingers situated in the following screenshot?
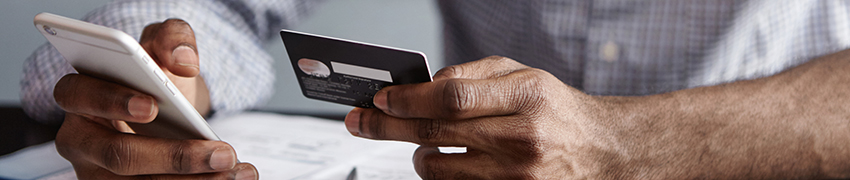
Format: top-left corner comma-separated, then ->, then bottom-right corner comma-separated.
54,19 -> 258,179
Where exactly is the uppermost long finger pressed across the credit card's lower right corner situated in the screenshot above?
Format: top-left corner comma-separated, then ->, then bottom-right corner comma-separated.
374,69 -> 546,120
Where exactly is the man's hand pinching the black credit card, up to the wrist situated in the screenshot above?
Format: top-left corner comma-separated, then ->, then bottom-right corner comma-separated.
345,56 -> 618,179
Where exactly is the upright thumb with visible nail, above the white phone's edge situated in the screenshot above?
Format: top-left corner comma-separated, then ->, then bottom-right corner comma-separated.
139,19 -> 200,77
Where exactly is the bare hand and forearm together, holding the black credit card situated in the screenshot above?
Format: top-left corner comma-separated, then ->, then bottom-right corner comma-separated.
345,50 -> 850,179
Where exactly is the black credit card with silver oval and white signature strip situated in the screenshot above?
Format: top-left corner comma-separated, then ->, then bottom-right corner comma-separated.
280,29 -> 431,108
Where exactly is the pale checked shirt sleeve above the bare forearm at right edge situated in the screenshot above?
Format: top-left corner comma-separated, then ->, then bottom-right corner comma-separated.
688,0 -> 850,87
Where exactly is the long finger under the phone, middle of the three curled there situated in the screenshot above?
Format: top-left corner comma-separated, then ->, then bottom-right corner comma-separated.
56,114 -> 237,175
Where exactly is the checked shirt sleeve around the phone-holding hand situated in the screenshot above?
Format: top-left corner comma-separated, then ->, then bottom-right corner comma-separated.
21,0 -> 315,124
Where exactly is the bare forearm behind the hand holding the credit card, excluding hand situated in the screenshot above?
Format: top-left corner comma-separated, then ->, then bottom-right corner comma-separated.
601,50 -> 850,179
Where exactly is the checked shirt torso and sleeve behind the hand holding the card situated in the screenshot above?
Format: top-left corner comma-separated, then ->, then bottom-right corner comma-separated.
438,0 -> 850,96
